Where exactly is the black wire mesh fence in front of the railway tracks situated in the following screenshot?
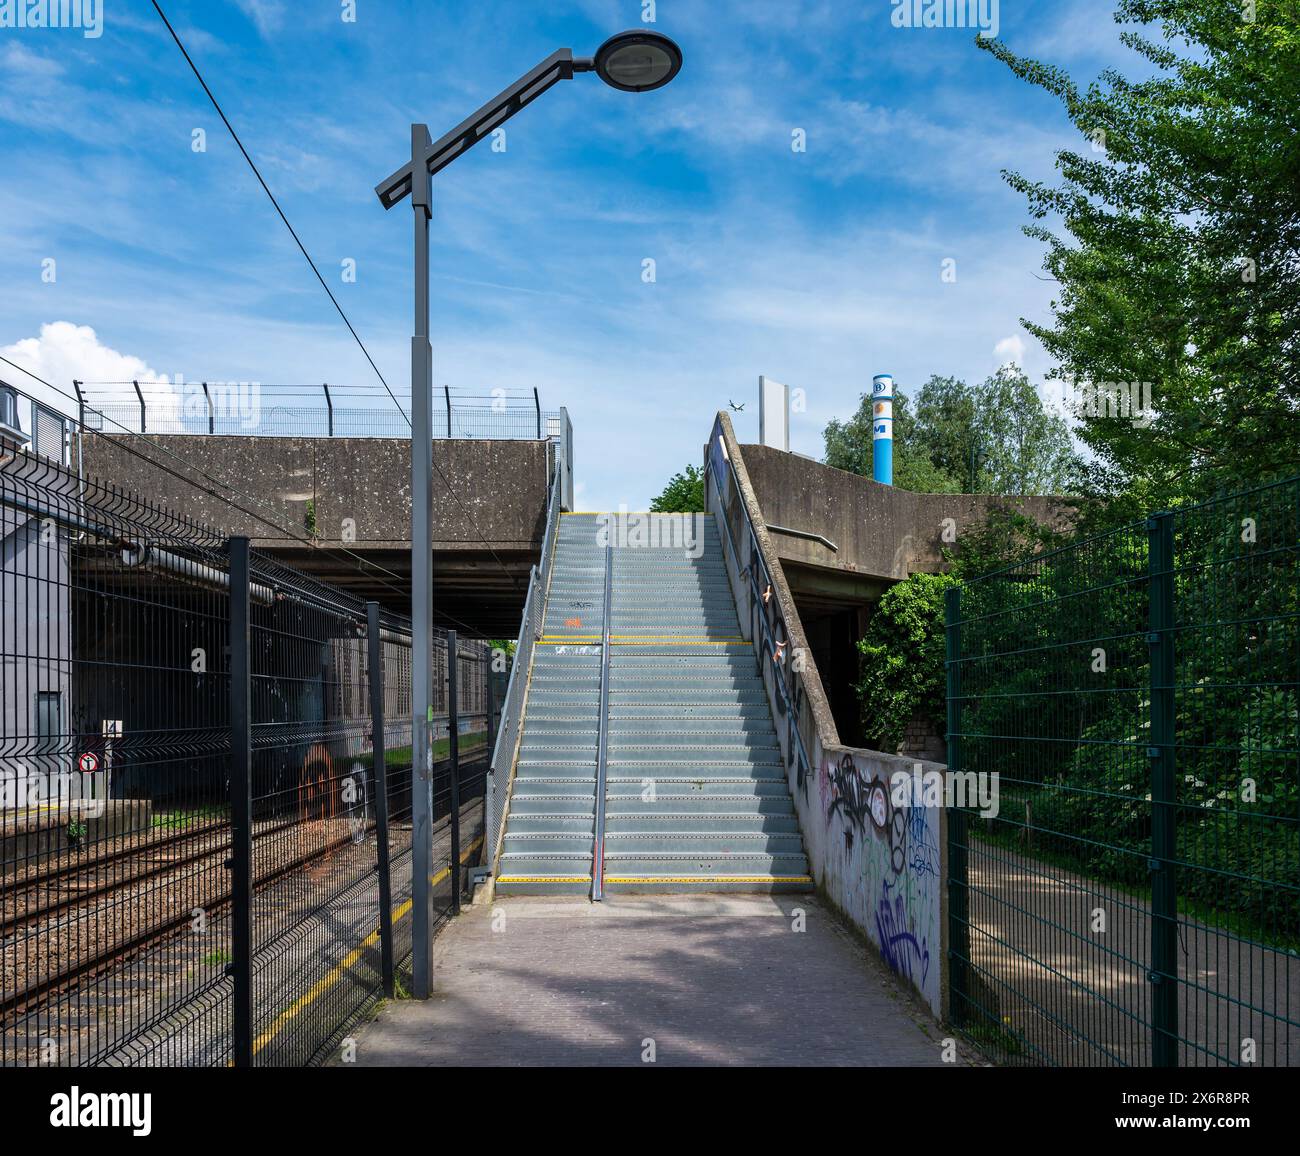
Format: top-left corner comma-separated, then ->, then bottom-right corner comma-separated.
0,442 -> 495,1065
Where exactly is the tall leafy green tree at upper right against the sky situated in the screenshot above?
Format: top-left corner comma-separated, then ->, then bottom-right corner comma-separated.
978,0 -> 1300,516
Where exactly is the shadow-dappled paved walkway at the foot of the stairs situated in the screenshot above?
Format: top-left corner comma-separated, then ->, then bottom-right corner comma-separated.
356,895 -> 961,1066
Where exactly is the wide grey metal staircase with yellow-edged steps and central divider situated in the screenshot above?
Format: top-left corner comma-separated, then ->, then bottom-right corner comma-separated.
497,514 -> 813,899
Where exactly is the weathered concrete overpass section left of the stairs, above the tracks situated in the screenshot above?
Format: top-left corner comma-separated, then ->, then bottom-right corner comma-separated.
82,433 -> 572,638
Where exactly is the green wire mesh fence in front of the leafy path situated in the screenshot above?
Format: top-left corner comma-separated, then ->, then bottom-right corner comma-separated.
948,479 -> 1300,1066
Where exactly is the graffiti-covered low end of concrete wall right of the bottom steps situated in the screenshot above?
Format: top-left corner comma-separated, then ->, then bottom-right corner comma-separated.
818,752 -> 941,1010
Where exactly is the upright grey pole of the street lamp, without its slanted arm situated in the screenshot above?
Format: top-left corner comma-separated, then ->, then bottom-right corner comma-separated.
411,125 -> 433,1000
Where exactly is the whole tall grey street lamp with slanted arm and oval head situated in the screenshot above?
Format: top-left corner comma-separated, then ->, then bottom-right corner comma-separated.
374,29 -> 681,999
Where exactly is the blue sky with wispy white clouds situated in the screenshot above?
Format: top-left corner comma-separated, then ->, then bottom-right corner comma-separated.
0,0 -> 1159,508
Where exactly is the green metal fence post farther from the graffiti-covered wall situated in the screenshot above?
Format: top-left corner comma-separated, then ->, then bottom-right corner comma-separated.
1147,511 -> 1178,1068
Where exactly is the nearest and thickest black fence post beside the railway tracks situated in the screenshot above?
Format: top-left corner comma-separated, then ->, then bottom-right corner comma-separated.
226,538 -> 252,1068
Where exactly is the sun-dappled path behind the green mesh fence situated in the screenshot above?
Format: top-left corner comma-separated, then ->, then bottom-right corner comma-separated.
970,840 -> 1300,1068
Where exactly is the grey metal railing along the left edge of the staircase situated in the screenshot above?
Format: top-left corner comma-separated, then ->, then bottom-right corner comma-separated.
481,463 -> 564,870
